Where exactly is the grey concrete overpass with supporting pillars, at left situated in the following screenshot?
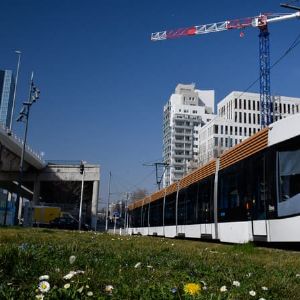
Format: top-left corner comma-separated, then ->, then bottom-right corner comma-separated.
0,126 -> 100,228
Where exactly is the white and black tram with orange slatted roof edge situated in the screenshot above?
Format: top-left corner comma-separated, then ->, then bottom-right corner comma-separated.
129,114 -> 300,243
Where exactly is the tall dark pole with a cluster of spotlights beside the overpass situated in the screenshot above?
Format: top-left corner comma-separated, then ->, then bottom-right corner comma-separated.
14,72 -> 40,225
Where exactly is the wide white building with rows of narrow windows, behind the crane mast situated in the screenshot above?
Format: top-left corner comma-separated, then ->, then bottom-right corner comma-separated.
196,91 -> 300,165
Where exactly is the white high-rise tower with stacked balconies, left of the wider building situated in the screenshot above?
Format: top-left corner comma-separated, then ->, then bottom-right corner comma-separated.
163,84 -> 215,186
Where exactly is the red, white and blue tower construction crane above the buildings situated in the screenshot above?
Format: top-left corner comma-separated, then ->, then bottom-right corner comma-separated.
151,9 -> 300,128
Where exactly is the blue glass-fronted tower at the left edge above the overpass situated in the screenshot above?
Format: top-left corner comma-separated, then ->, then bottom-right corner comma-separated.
0,70 -> 15,127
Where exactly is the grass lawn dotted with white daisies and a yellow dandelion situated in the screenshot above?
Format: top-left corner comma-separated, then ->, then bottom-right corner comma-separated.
0,229 -> 300,300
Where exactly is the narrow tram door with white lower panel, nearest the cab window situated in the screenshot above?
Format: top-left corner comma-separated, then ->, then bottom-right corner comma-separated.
252,156 -> 268,240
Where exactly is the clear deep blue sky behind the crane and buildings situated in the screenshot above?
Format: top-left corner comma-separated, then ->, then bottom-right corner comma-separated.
0,0 -> 300,201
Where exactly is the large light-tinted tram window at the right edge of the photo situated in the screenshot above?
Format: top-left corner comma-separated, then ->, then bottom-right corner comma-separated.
278,149 -> 300,216
